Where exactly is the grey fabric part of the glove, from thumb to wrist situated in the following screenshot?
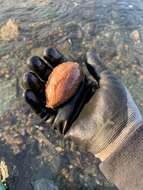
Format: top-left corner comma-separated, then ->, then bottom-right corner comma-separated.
66,51 -> 142,157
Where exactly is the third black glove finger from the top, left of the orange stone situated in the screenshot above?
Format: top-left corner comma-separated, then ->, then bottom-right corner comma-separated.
22,72 -> 45,102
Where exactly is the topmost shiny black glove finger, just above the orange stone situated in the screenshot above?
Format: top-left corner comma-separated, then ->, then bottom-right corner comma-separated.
44,48 -> 67,67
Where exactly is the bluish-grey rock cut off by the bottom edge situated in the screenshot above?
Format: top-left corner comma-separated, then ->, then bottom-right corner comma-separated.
32,178 -> 58,190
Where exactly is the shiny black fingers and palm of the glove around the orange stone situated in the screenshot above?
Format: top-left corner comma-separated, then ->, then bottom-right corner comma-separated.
23,48 -> 98,134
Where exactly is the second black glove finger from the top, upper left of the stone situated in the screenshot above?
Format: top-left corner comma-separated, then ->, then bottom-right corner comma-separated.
27,56 -> 52,81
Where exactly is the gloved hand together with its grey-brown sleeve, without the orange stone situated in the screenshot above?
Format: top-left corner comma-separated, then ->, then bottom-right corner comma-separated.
24,49 -> 143,190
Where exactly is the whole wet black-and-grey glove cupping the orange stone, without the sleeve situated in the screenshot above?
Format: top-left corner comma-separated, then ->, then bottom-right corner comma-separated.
24,49 -> 142,160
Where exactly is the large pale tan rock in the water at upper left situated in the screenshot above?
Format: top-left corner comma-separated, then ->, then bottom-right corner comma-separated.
0,19 -> 19,41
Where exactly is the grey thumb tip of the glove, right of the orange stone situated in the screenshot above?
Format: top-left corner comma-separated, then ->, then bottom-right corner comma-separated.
86,50 -> 106,78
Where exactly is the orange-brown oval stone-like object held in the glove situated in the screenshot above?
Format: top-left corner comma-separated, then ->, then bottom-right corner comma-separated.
45,62 -> 83,108
